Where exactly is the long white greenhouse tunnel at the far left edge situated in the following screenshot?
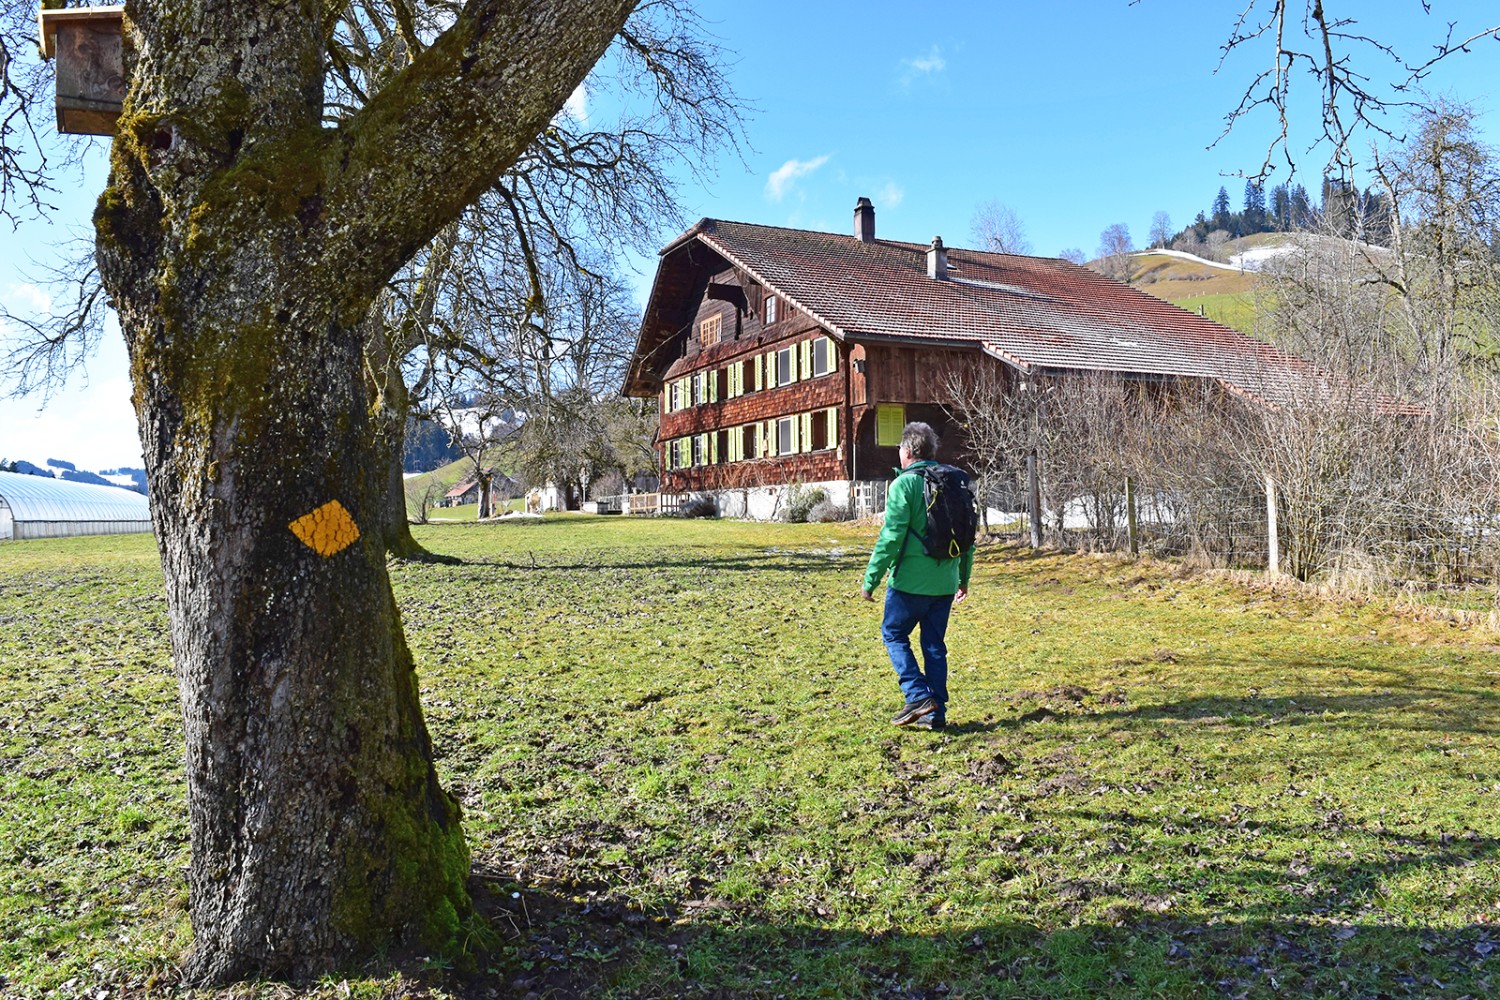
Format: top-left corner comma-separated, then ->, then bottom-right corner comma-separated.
0,472 -> 152,541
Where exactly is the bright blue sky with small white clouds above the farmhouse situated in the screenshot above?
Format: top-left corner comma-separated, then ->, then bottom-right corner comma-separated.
0,0 -> 1500,468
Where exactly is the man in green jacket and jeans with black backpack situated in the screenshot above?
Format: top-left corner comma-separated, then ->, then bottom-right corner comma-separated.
864,421 -> 978,729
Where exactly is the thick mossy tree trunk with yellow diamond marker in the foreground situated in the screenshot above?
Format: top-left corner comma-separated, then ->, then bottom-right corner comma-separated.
95,0 -> 633,984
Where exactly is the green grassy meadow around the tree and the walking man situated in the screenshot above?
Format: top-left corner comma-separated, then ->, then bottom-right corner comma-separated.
0,516 -> 1500,1000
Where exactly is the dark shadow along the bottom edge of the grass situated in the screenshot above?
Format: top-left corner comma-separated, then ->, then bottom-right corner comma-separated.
446,873 -> 1500,1000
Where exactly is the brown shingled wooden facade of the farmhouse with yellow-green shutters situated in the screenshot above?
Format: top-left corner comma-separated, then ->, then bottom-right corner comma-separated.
657,268 -> 999,493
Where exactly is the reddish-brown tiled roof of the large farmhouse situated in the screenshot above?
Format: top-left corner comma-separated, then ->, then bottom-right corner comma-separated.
630,219 -> 1404,409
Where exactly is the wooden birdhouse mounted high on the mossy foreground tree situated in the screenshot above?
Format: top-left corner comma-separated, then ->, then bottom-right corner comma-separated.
41,6 -> 125,135
